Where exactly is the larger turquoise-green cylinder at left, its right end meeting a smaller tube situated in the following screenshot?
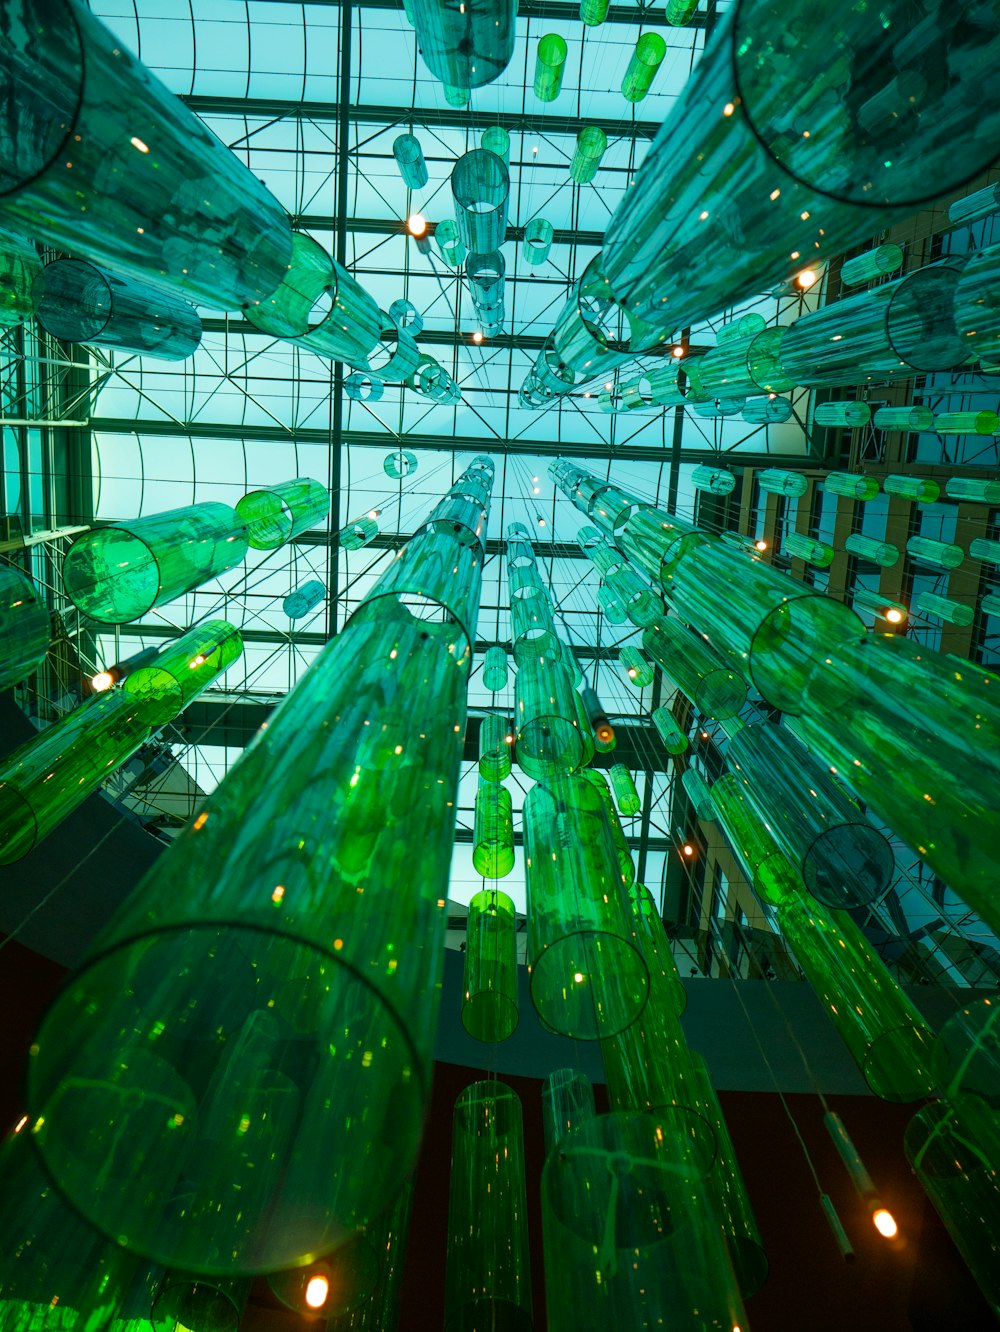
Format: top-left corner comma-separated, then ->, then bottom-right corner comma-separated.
63,503 -> 248,625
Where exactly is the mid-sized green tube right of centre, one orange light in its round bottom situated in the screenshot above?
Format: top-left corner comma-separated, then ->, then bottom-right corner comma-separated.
525,777 -> 648,1040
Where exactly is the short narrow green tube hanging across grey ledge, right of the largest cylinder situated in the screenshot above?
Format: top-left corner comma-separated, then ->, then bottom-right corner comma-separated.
462,888 -> 518,1042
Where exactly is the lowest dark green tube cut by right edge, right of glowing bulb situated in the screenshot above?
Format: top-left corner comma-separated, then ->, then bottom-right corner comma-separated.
903,1100 -> 1000,1316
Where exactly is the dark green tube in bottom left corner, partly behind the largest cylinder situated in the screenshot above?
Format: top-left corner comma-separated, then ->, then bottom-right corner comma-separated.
0,1122 -> 136,1332
